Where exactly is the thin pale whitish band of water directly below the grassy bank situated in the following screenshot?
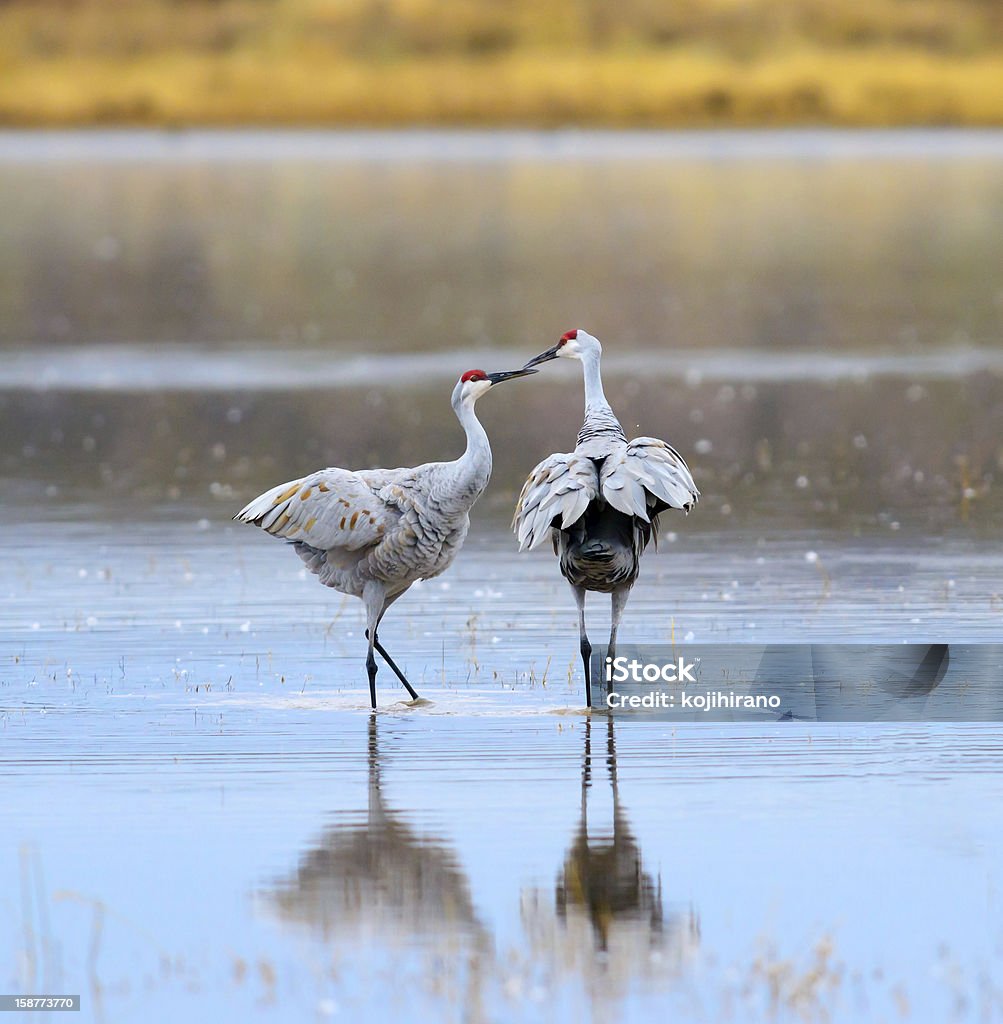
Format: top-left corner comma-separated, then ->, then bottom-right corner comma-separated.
0,125 -> 1003,165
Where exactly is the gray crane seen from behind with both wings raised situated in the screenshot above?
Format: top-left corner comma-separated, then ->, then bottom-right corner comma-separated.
512,331 -> 700,708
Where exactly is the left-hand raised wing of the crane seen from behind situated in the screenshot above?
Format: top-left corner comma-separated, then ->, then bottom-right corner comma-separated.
512,453 -> 599,551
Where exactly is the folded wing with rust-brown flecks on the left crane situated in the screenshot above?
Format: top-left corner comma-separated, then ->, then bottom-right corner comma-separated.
234,469 -> 393,551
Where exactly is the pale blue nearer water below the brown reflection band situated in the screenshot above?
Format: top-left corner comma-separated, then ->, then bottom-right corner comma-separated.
0,521 -> 1003,1021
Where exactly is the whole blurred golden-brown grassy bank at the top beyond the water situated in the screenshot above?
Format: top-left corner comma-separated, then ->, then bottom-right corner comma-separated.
0,0 -> 1003,126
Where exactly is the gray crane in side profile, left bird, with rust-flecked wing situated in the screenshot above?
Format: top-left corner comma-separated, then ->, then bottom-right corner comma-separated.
234,369 -> 536,709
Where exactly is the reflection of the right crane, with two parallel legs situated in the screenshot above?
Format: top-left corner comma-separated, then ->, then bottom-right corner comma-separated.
523,718 -> 700,1001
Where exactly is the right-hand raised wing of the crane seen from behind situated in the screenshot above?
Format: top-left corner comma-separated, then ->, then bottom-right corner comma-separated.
600,437 -> 700,522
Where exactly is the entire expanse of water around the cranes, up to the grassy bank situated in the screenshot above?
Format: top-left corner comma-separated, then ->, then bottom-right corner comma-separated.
0,133 -> 1003,1022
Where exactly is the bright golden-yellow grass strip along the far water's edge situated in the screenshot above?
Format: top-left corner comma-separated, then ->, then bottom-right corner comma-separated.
0,47 -> 1003,129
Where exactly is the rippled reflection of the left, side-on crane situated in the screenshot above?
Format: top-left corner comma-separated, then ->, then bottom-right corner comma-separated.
265,715 -> 491,955
